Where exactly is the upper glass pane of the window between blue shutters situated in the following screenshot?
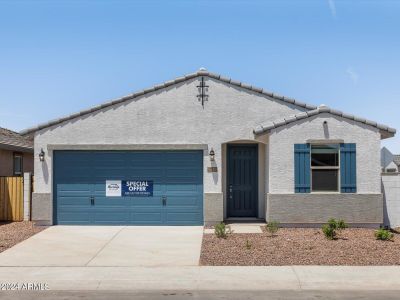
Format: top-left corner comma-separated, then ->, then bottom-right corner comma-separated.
311,145 -> 339,167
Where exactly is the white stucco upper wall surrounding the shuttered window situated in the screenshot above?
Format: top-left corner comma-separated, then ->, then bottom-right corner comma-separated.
269,114 -> 381,194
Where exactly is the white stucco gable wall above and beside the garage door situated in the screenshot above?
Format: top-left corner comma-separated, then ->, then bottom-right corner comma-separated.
35,78 -> 304,223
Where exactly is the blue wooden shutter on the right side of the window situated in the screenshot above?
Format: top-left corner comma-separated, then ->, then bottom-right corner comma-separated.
340,143 -> 357,193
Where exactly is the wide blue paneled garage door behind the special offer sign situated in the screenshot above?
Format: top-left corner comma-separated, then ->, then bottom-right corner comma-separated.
53,151 -> 203,225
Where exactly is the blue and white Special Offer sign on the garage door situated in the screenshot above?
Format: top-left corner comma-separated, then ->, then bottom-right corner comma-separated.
106,180 -> 153,197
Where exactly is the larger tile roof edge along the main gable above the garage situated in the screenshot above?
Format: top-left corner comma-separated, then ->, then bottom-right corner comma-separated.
20,68 -> 317,135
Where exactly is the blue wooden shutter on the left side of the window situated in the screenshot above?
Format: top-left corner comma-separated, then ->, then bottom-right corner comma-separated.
294,144 -> 311,193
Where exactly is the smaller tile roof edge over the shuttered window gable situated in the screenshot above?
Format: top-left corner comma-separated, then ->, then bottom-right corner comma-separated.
254,105 -> 396,136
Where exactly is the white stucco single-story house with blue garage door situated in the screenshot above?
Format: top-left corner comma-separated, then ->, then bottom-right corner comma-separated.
23,70 -> 396,226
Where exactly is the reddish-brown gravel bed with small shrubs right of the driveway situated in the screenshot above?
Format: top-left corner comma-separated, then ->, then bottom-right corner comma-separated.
200,228 -> 400,266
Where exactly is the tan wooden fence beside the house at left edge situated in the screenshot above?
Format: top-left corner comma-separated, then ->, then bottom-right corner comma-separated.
0,176 -> 24,221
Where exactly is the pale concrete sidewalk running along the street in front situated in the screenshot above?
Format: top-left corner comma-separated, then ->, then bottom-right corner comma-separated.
0,266 -> 400,291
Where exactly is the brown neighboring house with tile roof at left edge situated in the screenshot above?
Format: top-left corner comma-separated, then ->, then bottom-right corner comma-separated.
0,127 -> 33,176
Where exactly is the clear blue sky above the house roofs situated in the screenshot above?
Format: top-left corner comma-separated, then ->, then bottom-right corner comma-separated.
0,0 -> 400,153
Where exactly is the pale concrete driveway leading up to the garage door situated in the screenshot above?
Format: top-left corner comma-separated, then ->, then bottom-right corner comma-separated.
0,226 -> 203,267
